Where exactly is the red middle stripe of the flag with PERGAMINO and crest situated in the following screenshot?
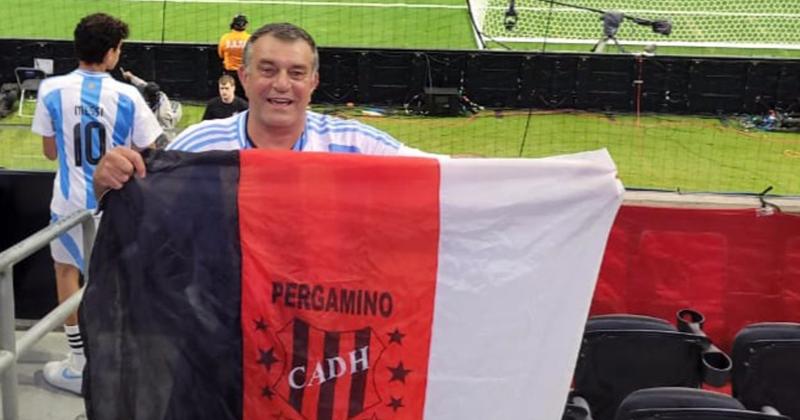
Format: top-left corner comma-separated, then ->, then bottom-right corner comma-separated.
239,151 -> 439,420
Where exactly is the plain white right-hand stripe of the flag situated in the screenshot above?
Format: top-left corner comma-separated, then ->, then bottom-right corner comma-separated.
425,150 -> 623,420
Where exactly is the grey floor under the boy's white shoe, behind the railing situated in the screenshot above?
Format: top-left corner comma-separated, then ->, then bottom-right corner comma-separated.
0,332 -> 85,420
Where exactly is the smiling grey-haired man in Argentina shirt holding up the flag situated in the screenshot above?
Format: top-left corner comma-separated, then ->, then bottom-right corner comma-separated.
94,23 -> 428,194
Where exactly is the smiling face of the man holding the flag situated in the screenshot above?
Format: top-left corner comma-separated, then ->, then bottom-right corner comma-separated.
239,35 -> 319,130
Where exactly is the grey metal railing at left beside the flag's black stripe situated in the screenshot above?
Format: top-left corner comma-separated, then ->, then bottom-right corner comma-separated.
0,210 -> 95,420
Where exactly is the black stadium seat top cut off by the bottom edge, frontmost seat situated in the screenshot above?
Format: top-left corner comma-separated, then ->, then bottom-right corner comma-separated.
614,387 -> 790,420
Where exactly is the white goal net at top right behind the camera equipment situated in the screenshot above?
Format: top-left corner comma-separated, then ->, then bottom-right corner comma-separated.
469,0 -> 800,49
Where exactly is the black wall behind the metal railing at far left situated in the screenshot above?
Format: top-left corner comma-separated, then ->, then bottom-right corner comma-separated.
0,170 -> 58,319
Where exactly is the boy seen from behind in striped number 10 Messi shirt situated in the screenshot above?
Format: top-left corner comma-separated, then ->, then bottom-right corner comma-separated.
31,13 -> 162,394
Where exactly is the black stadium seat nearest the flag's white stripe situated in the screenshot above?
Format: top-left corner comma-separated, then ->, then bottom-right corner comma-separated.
574,314 -> 730,420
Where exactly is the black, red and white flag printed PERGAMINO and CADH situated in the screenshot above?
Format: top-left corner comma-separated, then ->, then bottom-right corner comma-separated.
80,150 -> 622,420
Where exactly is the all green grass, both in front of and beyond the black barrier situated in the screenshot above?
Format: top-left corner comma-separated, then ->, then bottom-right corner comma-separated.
0,0 -> 800,195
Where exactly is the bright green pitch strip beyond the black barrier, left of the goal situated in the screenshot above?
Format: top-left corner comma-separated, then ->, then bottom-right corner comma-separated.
0,0 -> 475,49
